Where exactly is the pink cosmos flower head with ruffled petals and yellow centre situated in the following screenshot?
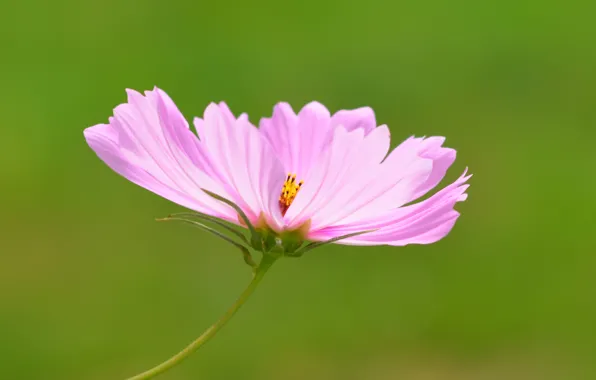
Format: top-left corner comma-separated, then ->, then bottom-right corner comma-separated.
85,88 -> 470,251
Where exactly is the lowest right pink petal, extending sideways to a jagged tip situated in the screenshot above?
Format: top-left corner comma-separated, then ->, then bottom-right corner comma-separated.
309,172 -> 471,246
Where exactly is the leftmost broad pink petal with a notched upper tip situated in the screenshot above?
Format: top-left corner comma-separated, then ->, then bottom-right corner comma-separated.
85,89 -> 280,223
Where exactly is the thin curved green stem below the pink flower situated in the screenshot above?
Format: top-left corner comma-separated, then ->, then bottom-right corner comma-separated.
127,254 -> 277,380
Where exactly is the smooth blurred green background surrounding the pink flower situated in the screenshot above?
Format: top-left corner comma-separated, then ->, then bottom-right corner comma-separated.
0,0 -> 596,380
